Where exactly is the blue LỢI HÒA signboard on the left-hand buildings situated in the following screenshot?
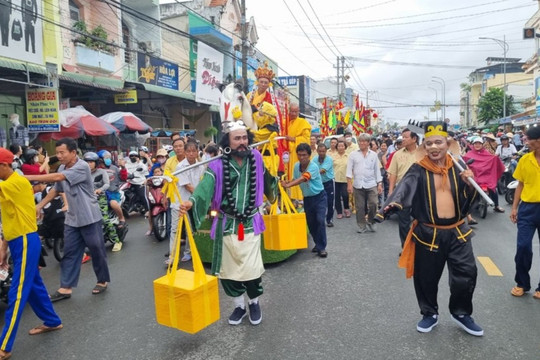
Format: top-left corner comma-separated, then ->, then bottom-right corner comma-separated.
137,53 -> 178,90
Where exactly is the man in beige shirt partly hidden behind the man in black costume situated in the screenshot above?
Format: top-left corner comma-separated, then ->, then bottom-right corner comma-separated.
388,129 -> 418,247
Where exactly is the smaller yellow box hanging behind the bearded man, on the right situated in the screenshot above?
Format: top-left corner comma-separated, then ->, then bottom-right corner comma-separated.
263,213 -> 307,250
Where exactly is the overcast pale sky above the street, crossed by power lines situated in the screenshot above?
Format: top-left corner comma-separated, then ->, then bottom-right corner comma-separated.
246,0 -> 538,123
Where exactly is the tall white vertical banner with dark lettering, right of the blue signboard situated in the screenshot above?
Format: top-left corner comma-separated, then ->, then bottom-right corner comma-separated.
195,41 -> 223,105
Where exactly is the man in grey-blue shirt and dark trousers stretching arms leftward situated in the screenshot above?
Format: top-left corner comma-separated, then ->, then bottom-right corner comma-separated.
26,138 -> 110,302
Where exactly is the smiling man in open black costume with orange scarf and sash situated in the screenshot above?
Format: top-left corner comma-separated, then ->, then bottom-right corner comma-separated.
376,121 -> 484,336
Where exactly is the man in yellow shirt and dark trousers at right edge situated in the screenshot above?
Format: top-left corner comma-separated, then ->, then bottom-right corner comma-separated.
510,126 -> 540,300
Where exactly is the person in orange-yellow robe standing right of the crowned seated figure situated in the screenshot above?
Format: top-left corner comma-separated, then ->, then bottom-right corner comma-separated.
286,103 -> 311,200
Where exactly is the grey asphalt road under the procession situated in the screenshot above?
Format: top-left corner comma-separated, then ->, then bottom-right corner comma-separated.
4,201 -> 540,360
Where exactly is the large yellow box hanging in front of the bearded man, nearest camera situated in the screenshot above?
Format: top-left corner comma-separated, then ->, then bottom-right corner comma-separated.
154,269 -> 219,334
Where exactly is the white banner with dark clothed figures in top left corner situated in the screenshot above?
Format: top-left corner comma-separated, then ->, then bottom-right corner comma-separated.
0,0 -> 43,64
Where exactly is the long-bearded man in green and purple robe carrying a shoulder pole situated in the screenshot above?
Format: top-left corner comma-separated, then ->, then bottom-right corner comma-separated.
180,121 -> 278,325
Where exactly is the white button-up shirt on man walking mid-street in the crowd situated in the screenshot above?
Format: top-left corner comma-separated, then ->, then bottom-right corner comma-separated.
346,150 -> 382,189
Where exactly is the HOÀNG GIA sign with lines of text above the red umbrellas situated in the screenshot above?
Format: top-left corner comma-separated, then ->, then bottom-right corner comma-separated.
26,88 -> 60,132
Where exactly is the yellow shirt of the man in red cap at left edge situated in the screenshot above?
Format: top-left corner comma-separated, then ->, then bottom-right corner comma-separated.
0,172 -> 37,241
